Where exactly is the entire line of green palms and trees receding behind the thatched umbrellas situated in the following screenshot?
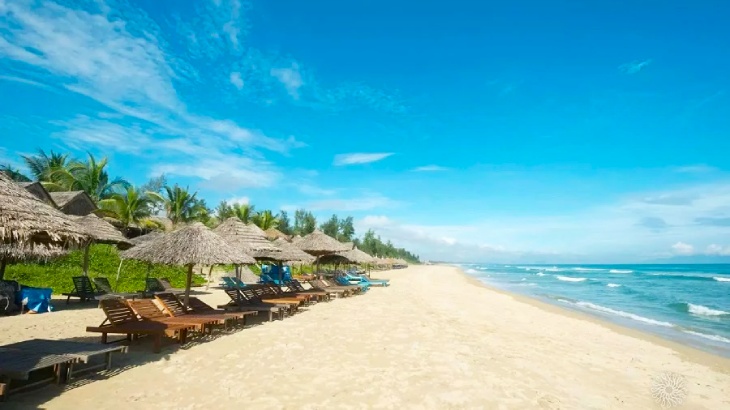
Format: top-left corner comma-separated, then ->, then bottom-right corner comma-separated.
0,150 -> 419,262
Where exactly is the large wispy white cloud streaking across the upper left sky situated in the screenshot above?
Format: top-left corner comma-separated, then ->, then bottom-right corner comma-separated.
0,0 -> 303,190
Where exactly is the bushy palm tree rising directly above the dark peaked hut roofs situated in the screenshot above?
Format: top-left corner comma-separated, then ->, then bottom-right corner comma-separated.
51,153 -> 131,203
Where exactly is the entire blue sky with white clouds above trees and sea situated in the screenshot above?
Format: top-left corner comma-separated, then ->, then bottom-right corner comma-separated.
0,0 -> 730,263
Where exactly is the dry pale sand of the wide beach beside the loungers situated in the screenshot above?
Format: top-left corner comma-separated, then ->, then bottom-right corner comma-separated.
0,266 -> 730,409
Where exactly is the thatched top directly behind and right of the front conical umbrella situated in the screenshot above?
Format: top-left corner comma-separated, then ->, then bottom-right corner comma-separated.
213,217 -> 286,261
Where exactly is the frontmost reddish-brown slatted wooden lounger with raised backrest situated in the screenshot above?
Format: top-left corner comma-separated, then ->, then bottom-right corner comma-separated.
86,299 -> 194,353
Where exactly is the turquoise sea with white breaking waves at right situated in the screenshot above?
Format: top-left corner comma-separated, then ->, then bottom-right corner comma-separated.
459,264 -> 730,357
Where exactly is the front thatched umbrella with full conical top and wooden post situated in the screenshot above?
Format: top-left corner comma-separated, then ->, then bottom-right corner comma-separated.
122,222 -> 256,306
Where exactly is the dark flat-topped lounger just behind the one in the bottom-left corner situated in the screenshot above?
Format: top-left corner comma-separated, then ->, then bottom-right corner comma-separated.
0,339 -> 127,380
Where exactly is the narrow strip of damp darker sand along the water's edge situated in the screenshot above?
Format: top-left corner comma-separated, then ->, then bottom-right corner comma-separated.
452,265 -> 730,374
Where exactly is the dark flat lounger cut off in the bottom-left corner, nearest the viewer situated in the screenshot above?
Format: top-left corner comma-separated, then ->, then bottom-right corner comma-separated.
0,347 -> 77,401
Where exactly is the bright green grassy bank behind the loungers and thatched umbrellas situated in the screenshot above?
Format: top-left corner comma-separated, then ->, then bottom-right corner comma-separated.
5,245 -> 204,294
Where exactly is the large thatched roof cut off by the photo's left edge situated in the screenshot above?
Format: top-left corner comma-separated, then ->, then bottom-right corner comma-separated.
0,173 -> 87,244
